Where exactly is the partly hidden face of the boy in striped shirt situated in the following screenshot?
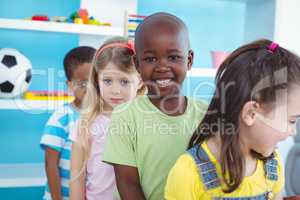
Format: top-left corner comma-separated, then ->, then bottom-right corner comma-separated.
67,63 -> 92,106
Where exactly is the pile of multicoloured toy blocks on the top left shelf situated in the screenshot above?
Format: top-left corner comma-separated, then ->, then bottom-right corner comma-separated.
67,9 -> 111,26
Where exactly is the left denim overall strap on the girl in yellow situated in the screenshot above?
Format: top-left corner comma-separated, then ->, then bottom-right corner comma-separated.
187,145 -> 220,190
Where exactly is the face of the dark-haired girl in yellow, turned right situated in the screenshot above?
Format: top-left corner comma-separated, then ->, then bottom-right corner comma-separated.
242,87 -> 300,156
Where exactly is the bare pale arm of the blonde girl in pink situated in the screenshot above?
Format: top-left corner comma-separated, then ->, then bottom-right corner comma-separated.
70,142 -> 86,200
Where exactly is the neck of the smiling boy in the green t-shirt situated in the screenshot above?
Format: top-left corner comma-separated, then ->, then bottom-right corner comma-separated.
149,95 -> 187,116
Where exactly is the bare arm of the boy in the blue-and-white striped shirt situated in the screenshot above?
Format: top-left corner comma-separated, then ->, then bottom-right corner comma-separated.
45,147 -> 62,200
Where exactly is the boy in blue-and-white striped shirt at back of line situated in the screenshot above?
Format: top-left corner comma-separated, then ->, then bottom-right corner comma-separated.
40,46 -> 95,200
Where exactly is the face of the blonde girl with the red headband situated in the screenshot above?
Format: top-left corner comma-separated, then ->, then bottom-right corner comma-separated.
98,62 -> 141,111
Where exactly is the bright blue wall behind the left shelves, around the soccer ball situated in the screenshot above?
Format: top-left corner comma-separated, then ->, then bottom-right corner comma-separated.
0,0 -> 80,199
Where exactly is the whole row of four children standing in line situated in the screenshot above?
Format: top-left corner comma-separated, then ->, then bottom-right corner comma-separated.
41,13 -> 300,200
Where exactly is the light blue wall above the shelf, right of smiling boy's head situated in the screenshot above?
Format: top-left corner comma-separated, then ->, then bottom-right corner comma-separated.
138,0 -> 246,67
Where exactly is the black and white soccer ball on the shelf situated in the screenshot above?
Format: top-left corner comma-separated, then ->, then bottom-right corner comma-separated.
0,48 -> 32,98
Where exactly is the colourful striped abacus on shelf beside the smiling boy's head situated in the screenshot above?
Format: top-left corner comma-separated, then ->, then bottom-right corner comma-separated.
124,12 -> 146,38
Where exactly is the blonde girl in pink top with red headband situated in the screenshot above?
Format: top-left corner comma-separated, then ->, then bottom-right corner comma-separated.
70,38 -> 143,200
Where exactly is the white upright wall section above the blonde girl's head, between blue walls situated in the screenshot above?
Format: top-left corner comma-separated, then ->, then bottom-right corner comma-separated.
79,0 -> 137,48
